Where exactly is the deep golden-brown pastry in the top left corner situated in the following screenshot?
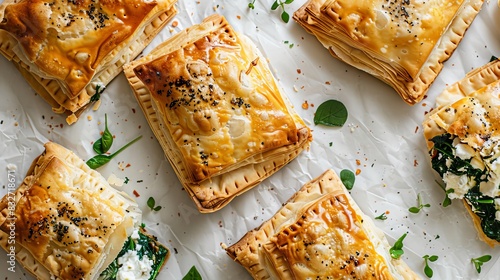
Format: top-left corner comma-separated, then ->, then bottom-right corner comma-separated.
0,0 -> 176,124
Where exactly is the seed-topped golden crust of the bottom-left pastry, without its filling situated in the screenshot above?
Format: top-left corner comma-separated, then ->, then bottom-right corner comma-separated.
0,142 -> 141,279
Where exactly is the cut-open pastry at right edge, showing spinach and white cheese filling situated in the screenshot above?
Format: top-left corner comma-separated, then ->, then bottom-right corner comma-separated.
423,60 -> 500,246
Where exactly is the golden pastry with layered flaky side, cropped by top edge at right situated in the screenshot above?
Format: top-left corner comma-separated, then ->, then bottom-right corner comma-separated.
293,0 -> 483,104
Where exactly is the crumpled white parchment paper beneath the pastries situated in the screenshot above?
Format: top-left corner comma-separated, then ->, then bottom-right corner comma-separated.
0,0 -> 500,279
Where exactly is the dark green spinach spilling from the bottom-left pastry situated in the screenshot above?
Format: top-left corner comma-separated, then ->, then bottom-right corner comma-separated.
99,231 -> 168,280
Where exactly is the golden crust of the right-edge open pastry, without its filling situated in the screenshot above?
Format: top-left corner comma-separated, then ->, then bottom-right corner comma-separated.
423,60 -> 500,247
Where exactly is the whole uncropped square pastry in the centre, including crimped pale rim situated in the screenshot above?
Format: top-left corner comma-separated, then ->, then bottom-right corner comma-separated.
124,15 -> 311,212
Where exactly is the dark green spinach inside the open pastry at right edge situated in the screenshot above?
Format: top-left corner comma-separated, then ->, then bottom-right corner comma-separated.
430,133 -> 500,241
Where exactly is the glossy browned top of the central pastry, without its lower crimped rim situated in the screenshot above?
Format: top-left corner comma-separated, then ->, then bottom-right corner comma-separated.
134,17 -> 304,184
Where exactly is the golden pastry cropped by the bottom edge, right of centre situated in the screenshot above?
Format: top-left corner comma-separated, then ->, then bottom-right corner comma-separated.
226,170 -> 419,279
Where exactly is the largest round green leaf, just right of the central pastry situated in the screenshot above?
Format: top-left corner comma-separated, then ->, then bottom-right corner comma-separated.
314,100 -> 347,126
